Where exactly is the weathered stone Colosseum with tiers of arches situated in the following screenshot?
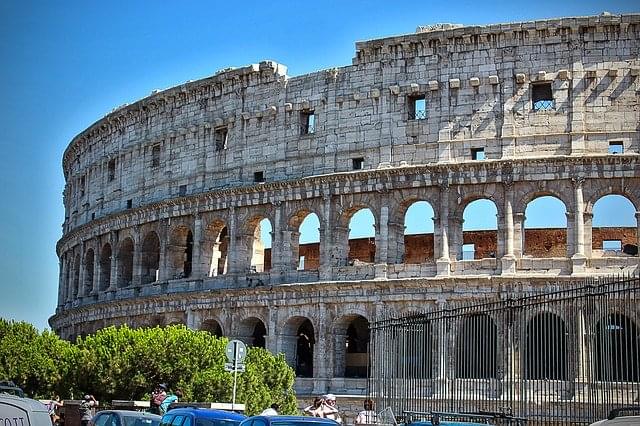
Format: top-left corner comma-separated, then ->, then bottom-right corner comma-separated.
50,14 -> 640,395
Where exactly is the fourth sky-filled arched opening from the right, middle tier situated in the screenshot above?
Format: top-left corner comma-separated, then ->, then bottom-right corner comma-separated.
404,201 -> 435,263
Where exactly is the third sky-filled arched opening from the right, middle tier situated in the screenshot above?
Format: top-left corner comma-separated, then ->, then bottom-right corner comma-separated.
459,198 -> 498,260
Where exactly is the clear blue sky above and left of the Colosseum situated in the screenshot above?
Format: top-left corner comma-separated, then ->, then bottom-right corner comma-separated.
0,0 -> 640,329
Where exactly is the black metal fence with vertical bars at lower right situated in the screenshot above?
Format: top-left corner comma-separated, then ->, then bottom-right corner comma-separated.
369,277 -> 640,424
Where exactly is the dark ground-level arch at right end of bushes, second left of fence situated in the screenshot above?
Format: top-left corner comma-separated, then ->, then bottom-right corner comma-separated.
283,316 -> 316,377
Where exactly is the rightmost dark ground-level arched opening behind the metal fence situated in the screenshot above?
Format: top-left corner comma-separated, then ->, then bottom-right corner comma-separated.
595,313 -> 640,382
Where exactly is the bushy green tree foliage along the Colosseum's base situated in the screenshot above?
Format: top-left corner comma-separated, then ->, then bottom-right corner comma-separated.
0,319 -> 296,414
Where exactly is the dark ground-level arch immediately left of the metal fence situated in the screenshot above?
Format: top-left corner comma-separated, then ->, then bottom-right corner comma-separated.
333,313 -> 369,378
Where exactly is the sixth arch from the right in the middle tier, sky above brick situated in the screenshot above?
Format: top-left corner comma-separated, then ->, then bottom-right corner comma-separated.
289,208 -> 321,270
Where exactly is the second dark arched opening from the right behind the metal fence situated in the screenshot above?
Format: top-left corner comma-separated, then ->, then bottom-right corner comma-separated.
524,312 -> 567,380
